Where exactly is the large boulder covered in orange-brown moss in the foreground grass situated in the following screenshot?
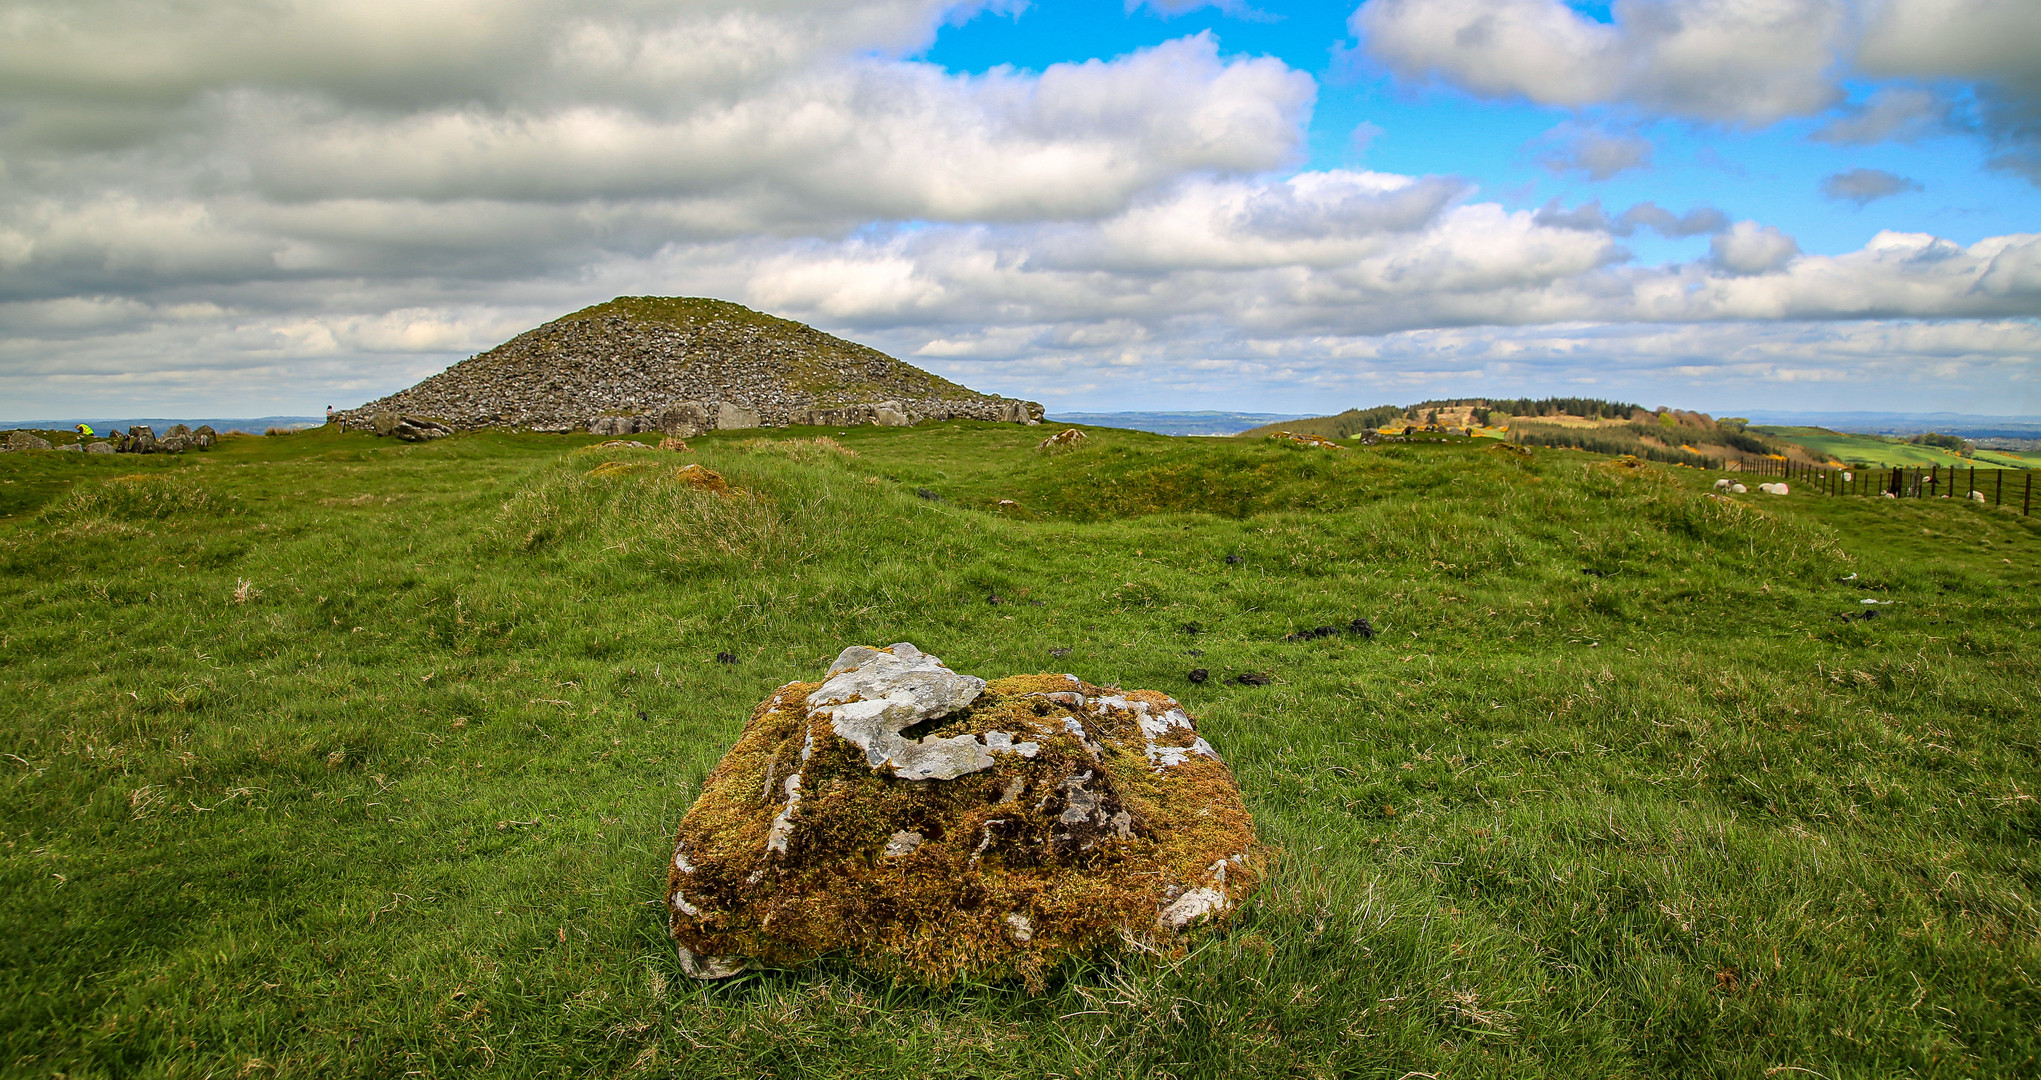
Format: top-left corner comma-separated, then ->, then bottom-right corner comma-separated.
667,641 -> 1267,988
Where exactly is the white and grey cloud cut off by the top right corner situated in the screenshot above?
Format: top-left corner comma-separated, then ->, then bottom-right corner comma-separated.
1349,0 -> 2041,184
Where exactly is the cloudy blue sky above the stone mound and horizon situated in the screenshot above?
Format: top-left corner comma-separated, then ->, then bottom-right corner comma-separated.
0,0 -> 2041,419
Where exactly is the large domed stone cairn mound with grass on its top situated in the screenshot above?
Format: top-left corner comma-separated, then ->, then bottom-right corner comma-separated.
337,296 -> 1041,439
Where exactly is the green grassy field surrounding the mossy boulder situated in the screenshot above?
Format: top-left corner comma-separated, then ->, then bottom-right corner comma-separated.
0,423 -> 2041,1080
